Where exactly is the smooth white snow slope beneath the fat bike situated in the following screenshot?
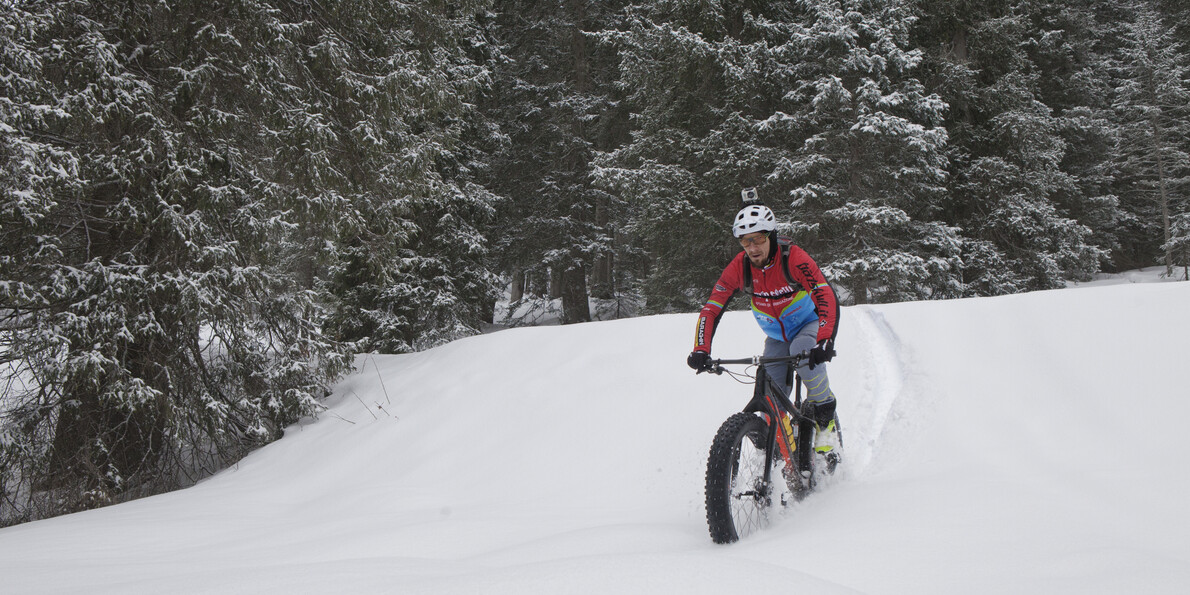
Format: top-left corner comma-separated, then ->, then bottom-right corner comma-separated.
0,275 -> 1190,594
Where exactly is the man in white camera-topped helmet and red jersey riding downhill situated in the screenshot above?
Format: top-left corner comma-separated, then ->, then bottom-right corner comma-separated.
687,188 -> 839,470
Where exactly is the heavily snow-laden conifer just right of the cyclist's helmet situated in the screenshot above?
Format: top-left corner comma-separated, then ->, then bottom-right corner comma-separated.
760,0 -> 962,303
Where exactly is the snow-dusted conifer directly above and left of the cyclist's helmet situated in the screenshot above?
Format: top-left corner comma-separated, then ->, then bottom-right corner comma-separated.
596,0 -> 796,312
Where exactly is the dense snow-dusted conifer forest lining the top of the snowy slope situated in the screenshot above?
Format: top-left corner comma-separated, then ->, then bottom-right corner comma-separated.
0,0 -> 1190,526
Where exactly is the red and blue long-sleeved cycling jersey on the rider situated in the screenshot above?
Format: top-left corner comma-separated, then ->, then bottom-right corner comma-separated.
694,245 -> 839,353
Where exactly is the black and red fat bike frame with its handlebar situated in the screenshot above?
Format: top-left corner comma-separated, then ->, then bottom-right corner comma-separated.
707,353 -> 809,489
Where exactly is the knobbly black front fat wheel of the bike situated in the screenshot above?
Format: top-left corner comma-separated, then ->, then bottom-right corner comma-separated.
707,413 -> 772,544
